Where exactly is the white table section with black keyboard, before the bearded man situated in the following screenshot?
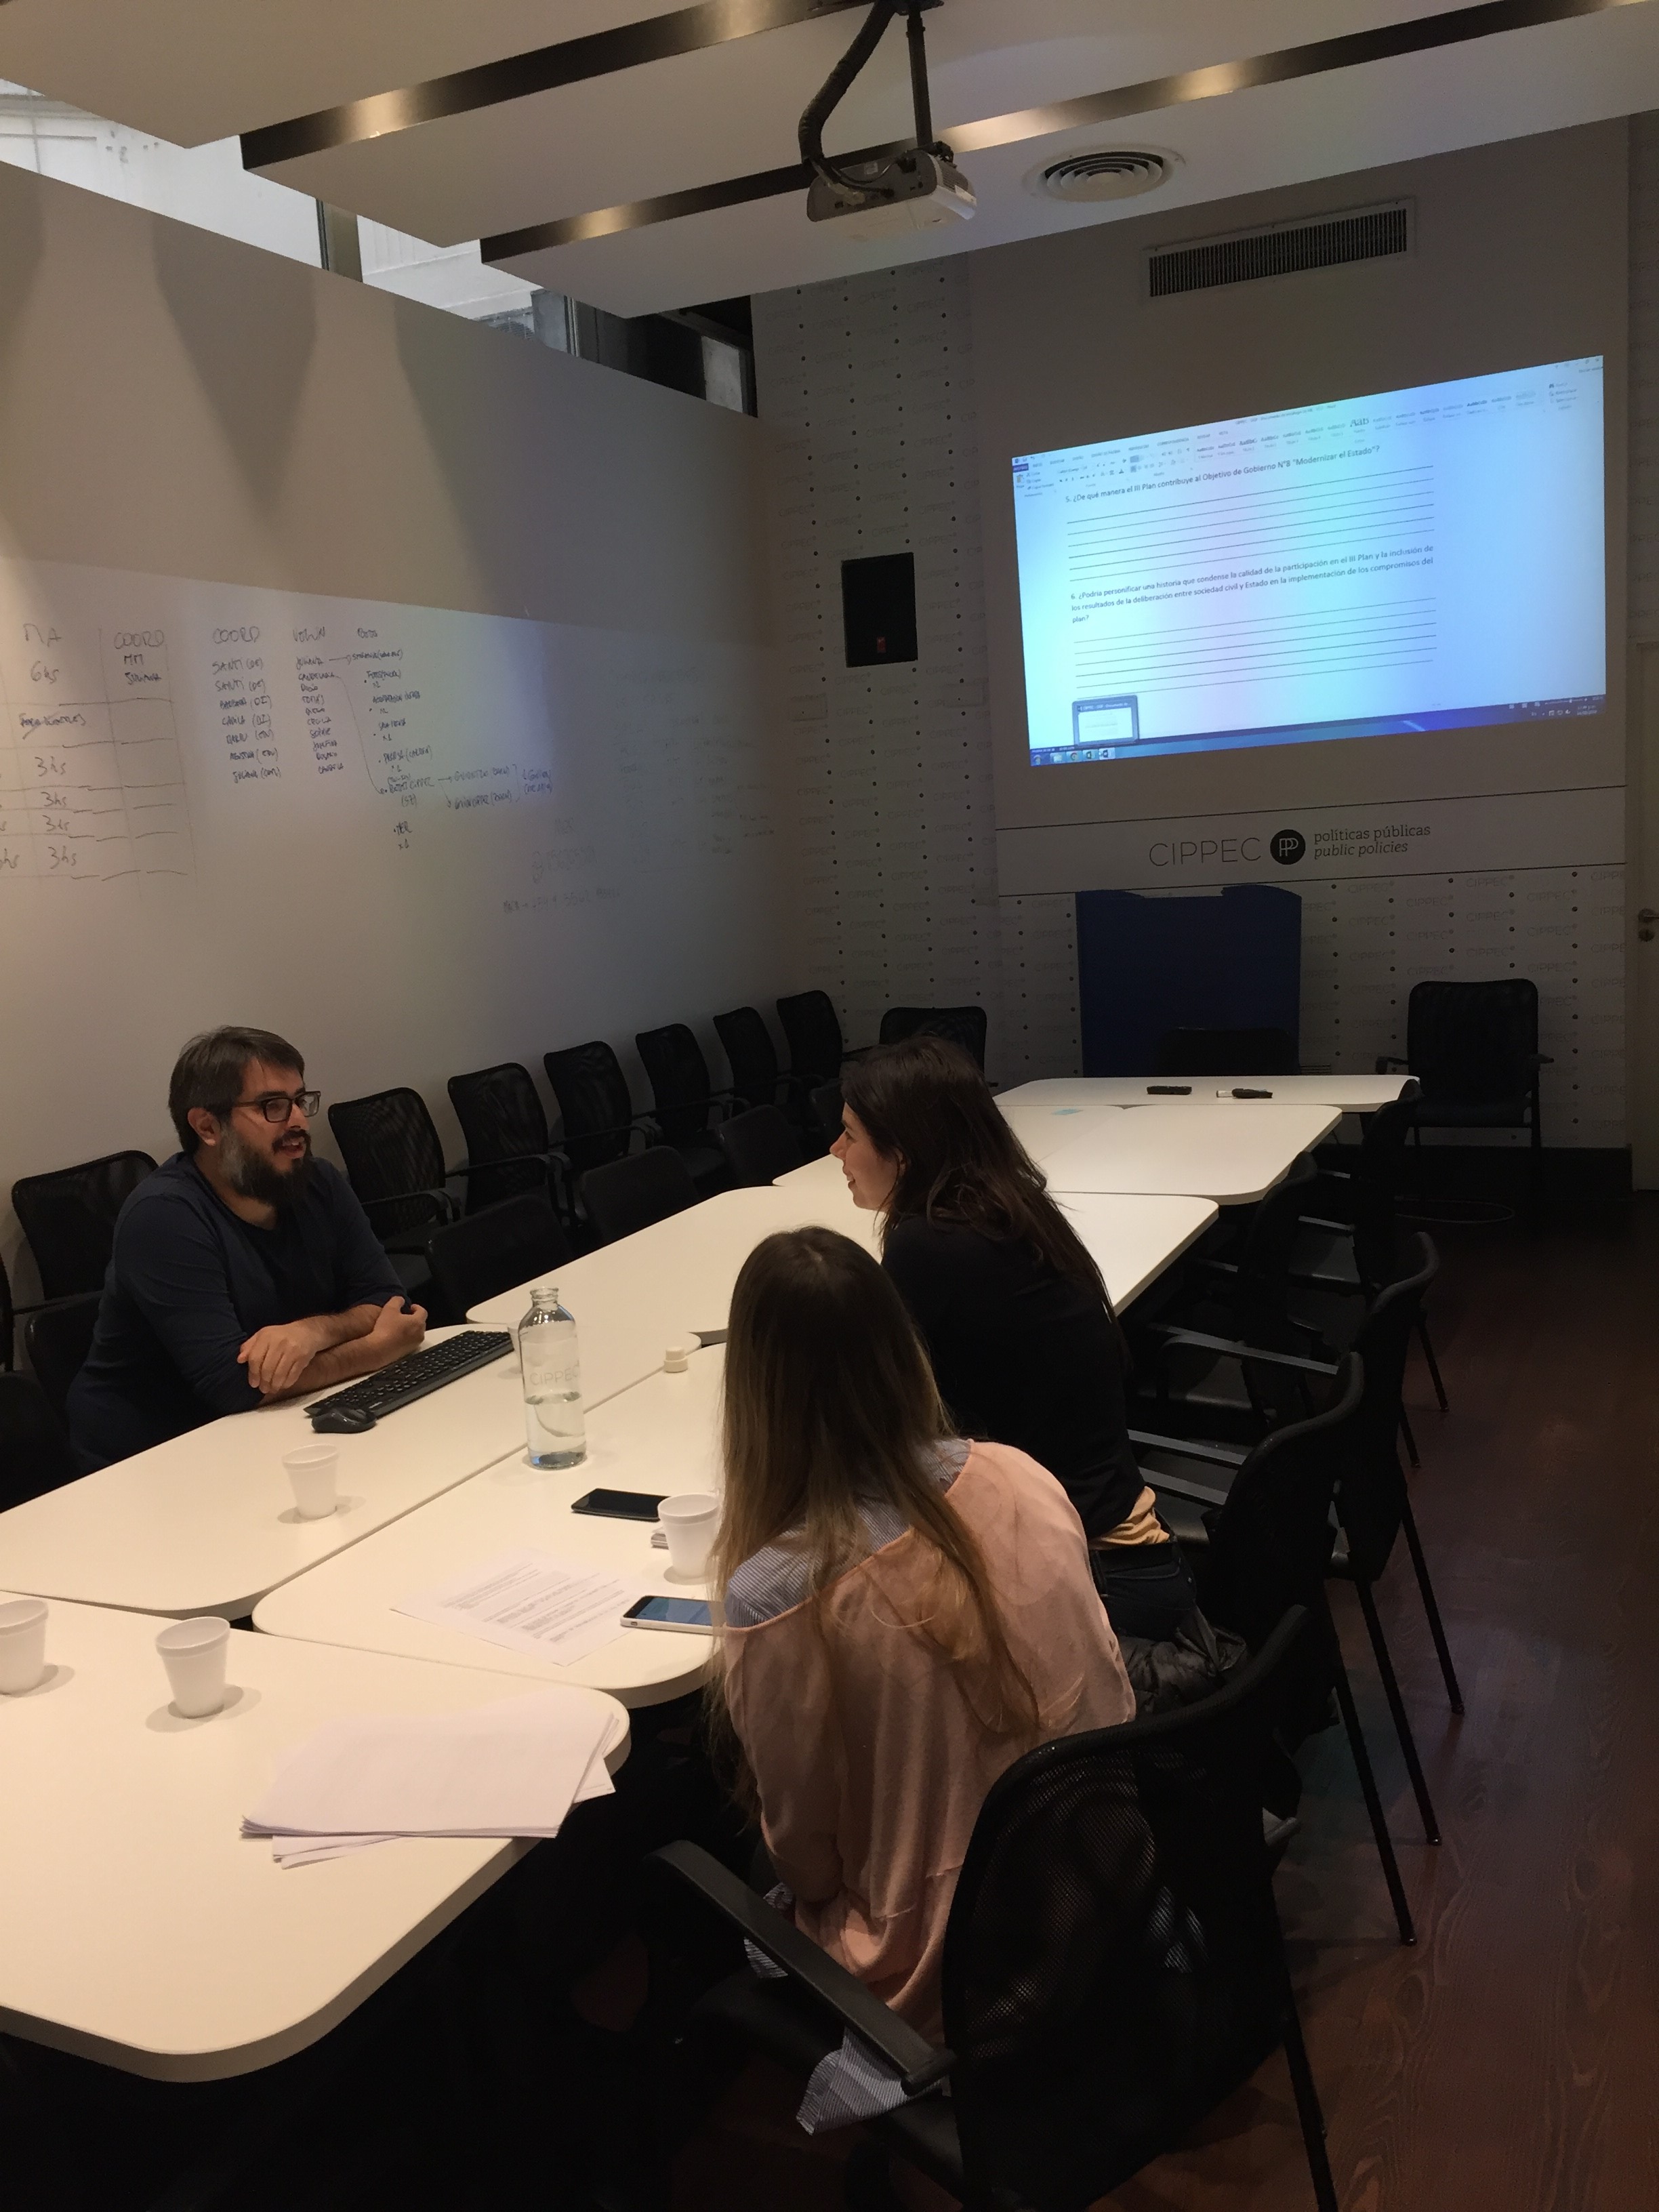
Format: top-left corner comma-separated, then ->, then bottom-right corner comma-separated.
0,1330 -> 526,1619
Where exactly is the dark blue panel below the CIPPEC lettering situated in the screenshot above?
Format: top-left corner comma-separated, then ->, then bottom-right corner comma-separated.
1078,882 -> 1303,1075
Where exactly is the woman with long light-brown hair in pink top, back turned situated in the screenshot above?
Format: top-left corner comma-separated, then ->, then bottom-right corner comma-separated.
710,1230 -> 1134,2035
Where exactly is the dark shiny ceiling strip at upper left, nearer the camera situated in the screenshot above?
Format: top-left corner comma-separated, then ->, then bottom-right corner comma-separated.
241,0 -> 889,168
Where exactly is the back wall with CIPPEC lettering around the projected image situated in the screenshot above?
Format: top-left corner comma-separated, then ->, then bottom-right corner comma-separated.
756,124 -> 1659,1146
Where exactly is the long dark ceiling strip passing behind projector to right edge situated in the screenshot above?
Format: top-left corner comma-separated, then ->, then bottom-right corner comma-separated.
483,0 -> 1654,263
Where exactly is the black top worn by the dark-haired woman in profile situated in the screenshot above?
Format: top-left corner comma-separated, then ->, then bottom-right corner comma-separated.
882,1216 -> 1146,1537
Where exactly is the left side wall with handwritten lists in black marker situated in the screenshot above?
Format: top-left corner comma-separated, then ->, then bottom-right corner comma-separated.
0,156 -> 792,1292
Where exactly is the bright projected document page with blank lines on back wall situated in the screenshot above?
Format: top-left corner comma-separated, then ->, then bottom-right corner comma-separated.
1013,356 -> 1606,765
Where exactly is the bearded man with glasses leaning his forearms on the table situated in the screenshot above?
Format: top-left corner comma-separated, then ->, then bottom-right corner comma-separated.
68,1029 -> 427,1473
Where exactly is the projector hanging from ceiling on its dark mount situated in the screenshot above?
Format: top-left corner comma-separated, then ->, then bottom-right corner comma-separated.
801,0 -> 975,239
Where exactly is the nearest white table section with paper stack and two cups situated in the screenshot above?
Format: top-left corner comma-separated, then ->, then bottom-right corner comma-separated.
0,1601 -> 628,2081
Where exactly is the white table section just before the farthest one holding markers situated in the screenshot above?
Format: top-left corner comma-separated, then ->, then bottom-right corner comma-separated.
1042,1099 -> 1343,1206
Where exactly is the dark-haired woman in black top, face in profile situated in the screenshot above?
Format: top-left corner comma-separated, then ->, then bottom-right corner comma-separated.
834,1038 -> 1197,1641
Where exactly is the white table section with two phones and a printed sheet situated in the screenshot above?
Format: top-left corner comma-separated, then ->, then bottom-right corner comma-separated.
254,1347 -> 723,1706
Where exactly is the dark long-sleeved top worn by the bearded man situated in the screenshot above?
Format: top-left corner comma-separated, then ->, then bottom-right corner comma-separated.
68,1153 -> 403,1475
